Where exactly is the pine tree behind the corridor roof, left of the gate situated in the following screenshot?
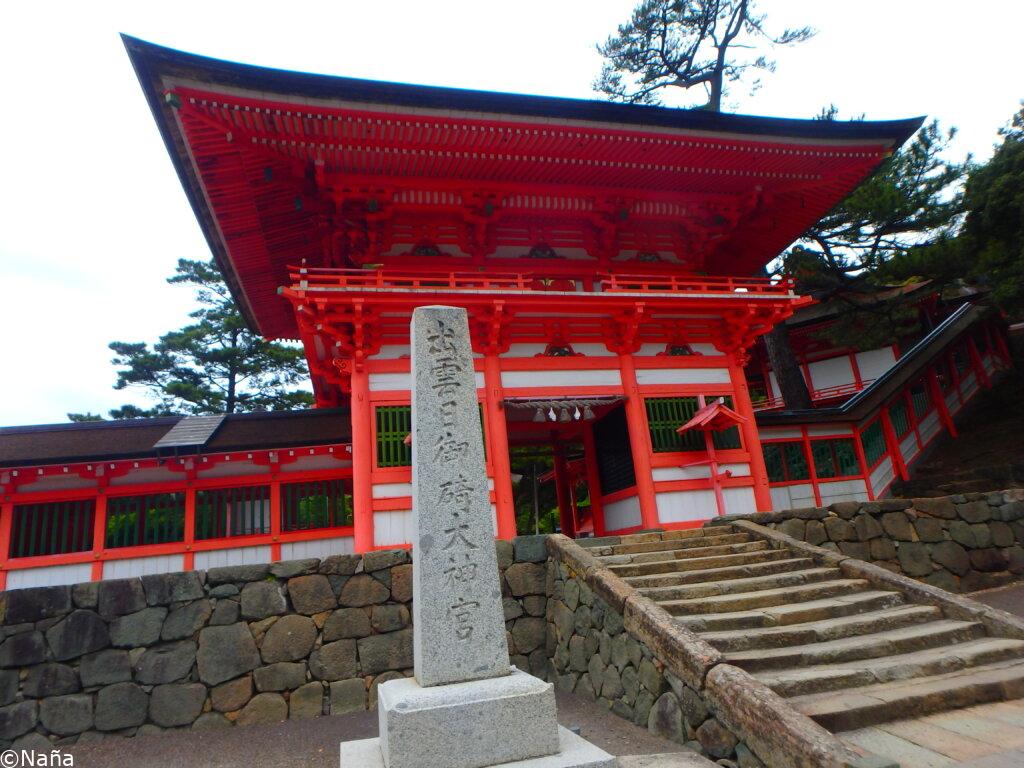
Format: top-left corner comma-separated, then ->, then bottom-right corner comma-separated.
95,259 -> 312,419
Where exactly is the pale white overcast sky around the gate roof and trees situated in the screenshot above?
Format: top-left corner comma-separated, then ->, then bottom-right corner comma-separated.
0,0 -> 1024,426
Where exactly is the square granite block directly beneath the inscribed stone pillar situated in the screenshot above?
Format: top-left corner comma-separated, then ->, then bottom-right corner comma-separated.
377,667 -> 558,768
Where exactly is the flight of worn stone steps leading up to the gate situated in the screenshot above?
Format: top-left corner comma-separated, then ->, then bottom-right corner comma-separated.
578,525 -> 1024,732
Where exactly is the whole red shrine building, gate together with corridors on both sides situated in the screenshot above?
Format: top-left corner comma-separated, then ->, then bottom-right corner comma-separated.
0,38 -> 1007,588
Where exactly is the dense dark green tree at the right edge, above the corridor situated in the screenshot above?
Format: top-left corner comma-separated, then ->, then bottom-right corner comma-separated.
954,108 -> 1024,318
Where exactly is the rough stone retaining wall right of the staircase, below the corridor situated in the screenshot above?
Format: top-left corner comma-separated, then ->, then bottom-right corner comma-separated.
713,488 -> 1024,592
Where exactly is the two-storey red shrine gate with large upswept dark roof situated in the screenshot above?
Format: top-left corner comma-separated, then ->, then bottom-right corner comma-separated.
0,39 -> 933,589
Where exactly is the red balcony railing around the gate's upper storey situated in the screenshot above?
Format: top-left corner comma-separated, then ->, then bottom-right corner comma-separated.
291,267 -> 797,298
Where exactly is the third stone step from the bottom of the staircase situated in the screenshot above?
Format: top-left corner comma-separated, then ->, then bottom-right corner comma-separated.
725,618 -> 985,673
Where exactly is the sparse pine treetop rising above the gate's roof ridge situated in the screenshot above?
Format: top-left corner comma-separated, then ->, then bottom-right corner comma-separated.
594,0 -> 814,112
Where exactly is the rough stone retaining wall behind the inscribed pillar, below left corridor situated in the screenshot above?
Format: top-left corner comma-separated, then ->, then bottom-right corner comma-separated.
0,537 -> 548,749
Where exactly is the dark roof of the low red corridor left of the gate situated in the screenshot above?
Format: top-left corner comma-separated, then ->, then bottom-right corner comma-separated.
0,409 -> 351,467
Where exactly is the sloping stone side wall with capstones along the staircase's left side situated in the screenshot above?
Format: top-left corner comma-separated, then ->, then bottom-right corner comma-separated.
548,535 -> 882,768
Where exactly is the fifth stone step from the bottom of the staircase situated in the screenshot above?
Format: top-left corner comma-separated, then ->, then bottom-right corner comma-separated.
676,590 -> 903,633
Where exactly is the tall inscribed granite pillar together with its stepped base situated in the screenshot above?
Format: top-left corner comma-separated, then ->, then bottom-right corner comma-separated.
341,306 -> 613,768
